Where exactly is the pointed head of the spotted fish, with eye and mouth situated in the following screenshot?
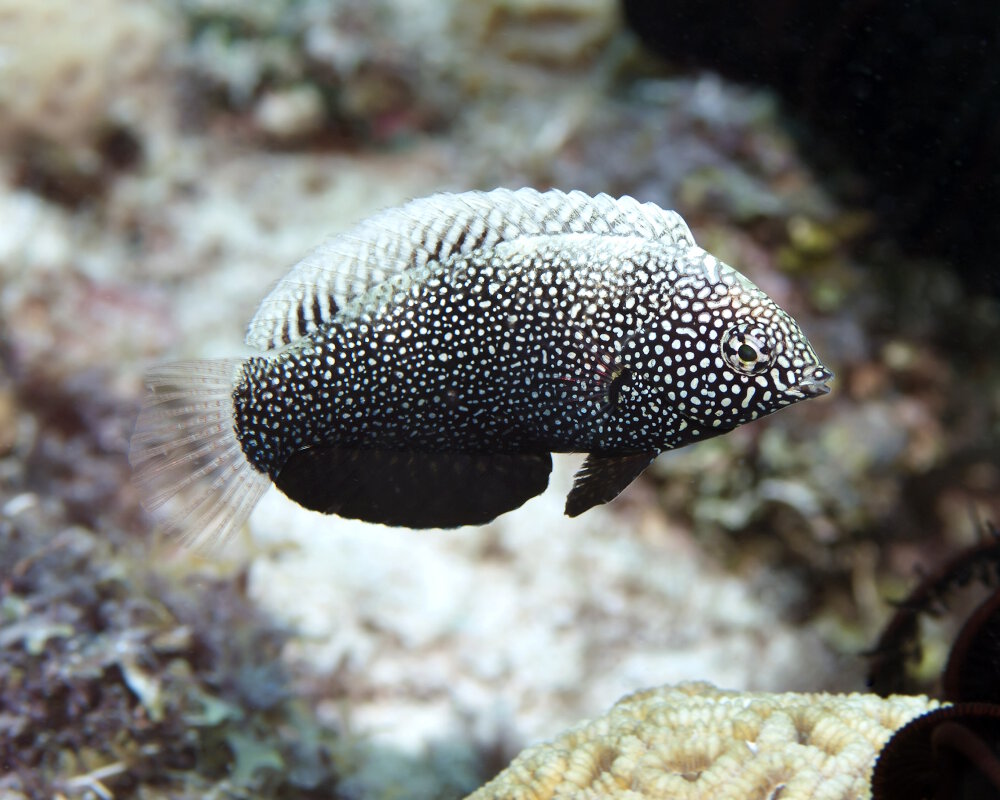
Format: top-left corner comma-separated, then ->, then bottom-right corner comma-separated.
671,254 -> 833,438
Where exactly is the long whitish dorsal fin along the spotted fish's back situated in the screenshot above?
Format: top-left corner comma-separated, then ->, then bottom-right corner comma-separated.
246,189 -> 694,350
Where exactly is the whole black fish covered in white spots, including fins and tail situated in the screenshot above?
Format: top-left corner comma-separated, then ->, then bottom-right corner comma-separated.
131,189 -> 832,539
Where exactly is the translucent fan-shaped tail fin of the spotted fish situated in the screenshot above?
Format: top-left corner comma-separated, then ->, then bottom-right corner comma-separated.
129,359 -> 270,547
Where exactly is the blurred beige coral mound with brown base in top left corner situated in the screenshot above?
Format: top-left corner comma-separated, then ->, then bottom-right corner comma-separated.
0,0 -> 178,203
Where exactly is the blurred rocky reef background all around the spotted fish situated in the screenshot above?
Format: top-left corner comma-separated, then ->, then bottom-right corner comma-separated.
0,0 -> 1000,798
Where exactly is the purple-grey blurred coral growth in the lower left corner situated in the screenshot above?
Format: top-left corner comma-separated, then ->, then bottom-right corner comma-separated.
0,360 -> 351,798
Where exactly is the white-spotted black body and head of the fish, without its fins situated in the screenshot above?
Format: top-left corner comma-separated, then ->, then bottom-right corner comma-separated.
234,206 -> 829,476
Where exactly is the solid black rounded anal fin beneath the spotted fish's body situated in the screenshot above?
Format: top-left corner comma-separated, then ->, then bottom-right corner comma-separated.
274,447 -> 552,528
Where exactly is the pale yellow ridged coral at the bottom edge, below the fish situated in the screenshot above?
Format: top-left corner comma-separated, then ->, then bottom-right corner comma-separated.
467,683 -> 940,800
